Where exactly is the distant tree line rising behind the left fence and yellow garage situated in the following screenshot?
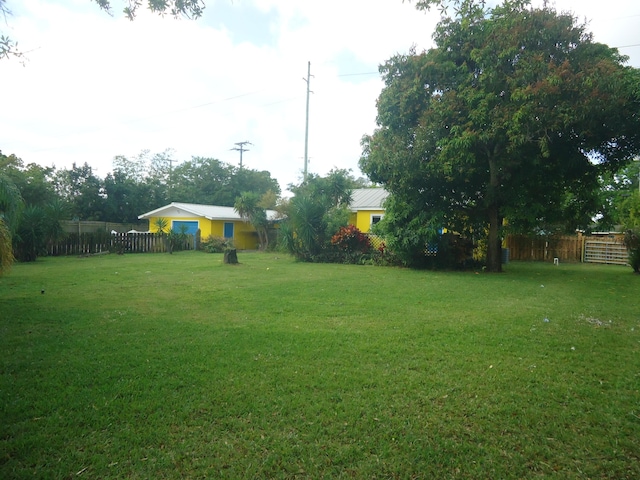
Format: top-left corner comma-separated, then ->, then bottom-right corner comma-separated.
0,151 -> 280,223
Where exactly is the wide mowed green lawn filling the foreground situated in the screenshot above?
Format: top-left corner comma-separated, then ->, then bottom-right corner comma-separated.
0,252 -> 640,479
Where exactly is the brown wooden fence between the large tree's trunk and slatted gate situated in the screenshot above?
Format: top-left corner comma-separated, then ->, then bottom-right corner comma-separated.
506,235 -> 584,262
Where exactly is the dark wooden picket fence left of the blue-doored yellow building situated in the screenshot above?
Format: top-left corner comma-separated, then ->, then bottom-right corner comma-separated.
47,231 -> 194,256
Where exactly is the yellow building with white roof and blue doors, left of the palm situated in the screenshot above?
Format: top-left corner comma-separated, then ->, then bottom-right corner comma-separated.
138,202 -> 277,250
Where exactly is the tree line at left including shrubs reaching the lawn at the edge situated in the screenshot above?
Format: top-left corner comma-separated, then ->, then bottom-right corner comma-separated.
0,151 -> 280,269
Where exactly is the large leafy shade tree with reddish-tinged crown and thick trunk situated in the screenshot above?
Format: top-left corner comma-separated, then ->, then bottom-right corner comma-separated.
360,0 -> 640,272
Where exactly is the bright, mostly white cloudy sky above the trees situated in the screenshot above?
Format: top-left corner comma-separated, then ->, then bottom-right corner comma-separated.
0,0 -> 640,192
